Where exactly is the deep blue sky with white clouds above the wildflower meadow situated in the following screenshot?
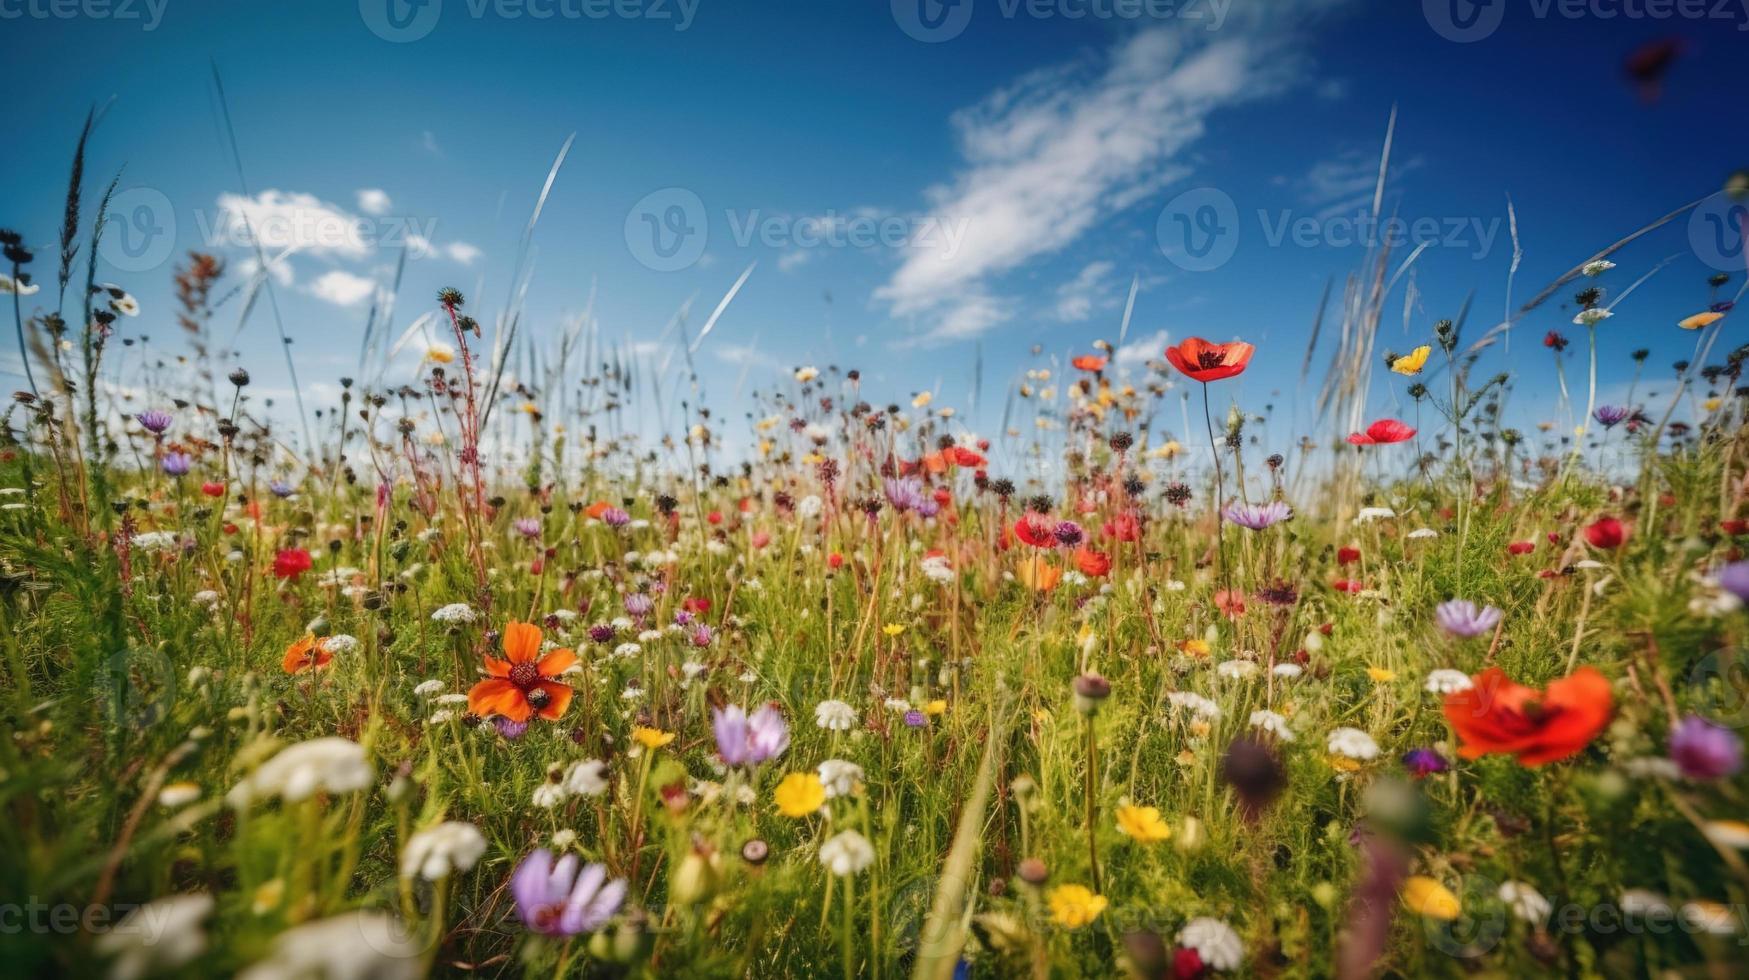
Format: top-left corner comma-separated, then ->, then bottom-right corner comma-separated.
0,0 -> 1749,458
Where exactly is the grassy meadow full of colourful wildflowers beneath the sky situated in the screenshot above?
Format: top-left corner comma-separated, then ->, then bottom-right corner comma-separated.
0,114 -> 1749,980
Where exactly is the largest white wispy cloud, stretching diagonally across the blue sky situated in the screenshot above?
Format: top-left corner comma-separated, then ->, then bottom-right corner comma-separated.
875,9 -> 1331,343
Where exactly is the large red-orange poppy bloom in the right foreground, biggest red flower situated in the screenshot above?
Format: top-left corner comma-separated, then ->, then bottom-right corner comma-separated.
1445,667 -> 1614,767
